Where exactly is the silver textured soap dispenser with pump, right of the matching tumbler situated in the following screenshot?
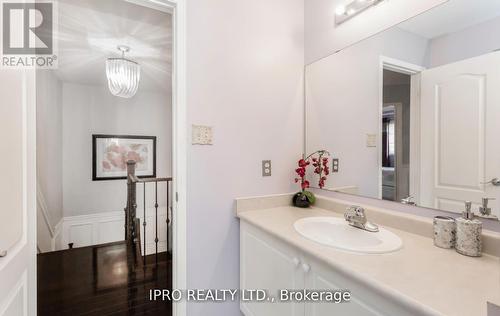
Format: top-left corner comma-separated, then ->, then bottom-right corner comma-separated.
455,201 -> 483,257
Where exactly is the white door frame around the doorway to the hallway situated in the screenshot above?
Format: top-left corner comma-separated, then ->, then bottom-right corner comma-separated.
31,0 -> 187,316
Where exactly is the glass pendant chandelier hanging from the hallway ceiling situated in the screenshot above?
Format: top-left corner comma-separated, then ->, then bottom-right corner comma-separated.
106,45 -> 141,98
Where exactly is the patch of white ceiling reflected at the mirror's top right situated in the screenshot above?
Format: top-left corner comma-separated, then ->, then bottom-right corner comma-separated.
398,0 -> 500,39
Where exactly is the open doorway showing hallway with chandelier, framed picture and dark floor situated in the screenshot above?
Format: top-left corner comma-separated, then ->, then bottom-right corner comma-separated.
37,0 -> 176,316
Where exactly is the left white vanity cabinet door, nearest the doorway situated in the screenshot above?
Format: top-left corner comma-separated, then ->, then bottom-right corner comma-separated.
240,222 -> 304,316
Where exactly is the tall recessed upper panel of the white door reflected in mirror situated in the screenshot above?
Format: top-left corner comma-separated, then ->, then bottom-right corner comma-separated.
434,74 -> 486,191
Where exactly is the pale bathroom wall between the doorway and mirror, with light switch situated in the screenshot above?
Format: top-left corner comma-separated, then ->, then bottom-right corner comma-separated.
187,0 -> 304,316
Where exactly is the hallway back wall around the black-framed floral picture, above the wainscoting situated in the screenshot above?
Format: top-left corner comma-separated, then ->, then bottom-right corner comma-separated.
62,83 -> 171,216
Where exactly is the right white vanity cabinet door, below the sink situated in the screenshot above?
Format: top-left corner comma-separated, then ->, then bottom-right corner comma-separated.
305,258 -> 424,316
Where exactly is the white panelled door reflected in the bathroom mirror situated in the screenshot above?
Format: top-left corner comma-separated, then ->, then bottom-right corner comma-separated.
420,52 -> 500,215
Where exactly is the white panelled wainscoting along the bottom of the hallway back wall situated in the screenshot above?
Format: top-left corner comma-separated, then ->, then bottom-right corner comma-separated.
59,207 -> 167,255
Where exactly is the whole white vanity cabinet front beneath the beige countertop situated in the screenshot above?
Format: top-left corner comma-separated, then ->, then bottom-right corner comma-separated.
240,221 -> 426,316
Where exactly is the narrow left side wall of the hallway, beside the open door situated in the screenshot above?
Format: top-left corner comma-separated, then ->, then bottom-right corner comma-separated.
36,70 -> 63,229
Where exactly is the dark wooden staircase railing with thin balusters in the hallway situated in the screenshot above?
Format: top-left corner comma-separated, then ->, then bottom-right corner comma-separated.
125,160 -> 172,265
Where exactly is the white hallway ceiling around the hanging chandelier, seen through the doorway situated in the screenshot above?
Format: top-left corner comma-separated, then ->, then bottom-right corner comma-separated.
56,0 -> 172,90
